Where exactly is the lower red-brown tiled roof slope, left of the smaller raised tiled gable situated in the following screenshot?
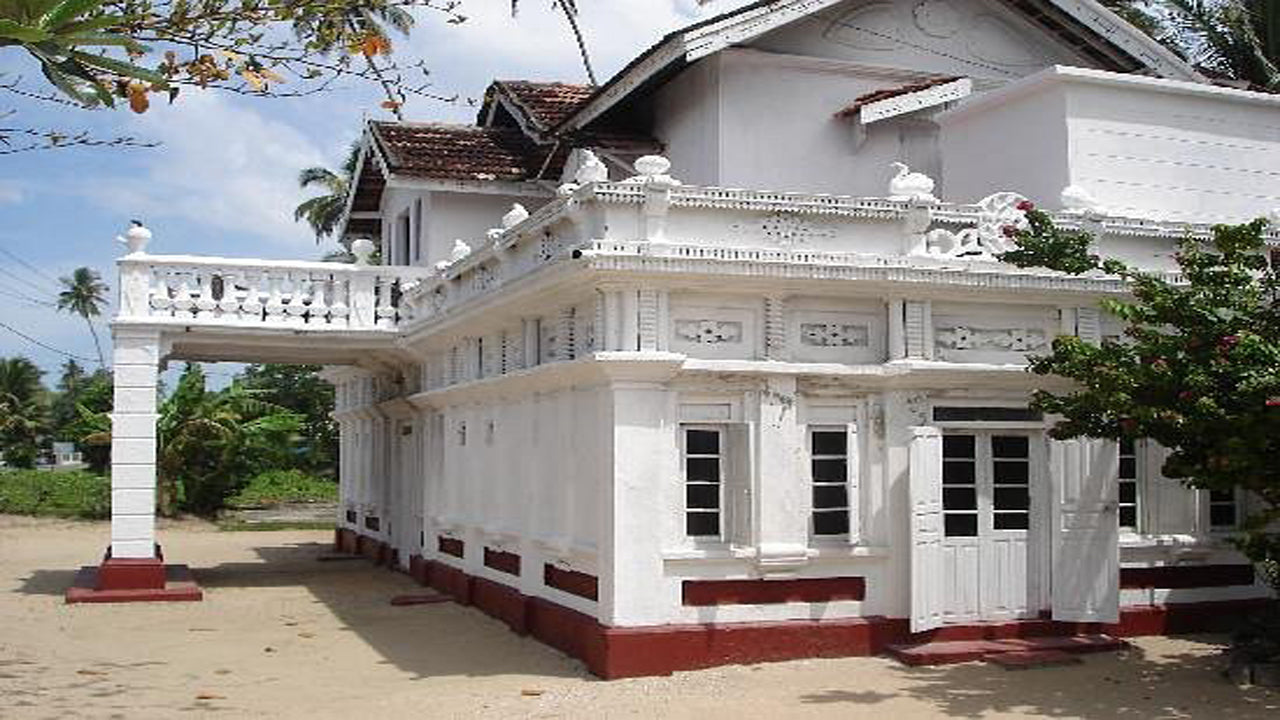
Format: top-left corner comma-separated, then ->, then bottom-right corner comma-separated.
370,123 -> 564,181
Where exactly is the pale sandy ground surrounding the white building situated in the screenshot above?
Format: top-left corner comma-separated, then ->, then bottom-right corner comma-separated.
0,516 -> 1280,720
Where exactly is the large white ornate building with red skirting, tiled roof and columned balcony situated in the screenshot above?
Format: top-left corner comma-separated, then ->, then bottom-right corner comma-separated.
85,0 -> 1280,676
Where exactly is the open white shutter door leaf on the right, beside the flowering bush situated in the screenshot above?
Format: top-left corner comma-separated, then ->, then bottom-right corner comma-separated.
1050,439 -> 1120,623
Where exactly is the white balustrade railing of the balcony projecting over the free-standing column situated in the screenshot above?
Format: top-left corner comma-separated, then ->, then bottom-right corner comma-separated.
116,252 -> 431,331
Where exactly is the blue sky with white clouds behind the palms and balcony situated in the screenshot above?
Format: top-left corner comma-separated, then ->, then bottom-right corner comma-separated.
0,0 -> 746,383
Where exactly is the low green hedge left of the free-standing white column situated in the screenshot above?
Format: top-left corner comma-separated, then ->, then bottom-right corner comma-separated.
0,470 -> 111,518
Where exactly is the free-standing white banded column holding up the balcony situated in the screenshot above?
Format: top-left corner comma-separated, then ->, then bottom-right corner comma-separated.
111,328 -> 160,559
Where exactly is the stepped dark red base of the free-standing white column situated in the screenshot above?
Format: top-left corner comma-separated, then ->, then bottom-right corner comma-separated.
67,546 -> 205,603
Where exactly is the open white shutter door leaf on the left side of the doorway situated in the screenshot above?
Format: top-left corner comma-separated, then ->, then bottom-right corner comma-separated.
908,427 -> 943,633
